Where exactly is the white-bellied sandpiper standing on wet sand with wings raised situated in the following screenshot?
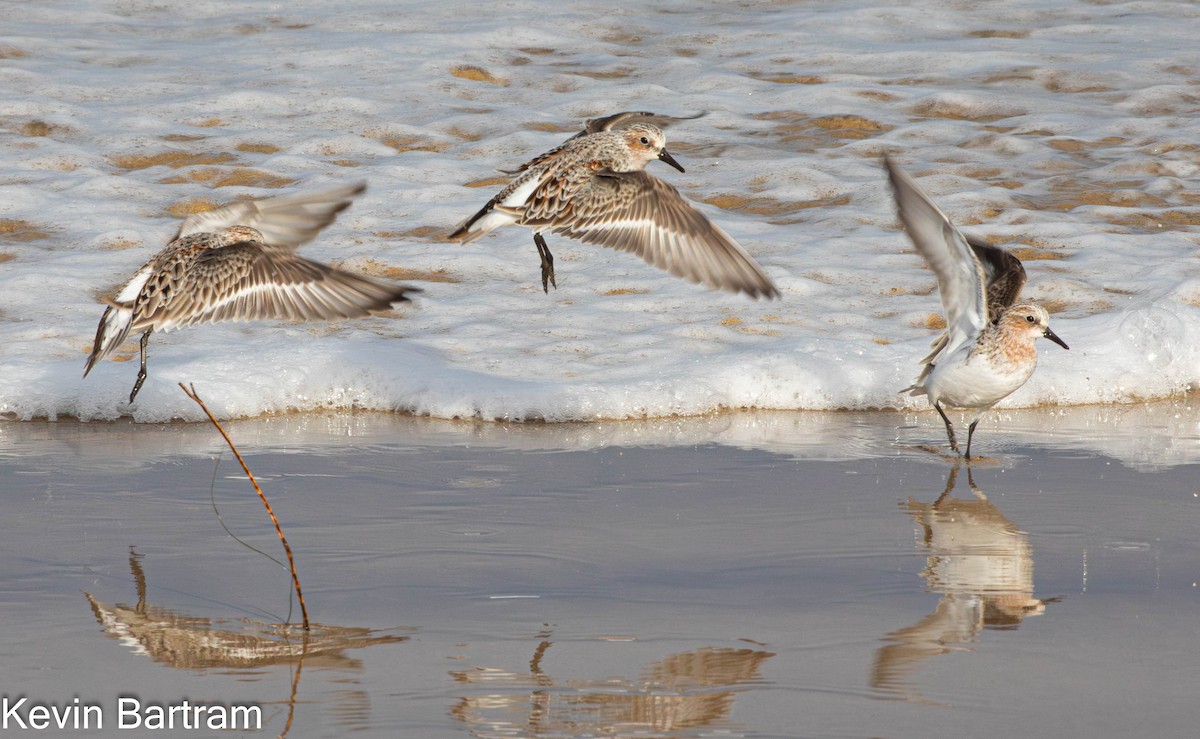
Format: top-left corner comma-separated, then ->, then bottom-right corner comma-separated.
884,158 -> 1069,461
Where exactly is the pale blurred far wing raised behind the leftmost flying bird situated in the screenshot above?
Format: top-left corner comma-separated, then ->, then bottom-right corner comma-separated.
173,182 -> 367,248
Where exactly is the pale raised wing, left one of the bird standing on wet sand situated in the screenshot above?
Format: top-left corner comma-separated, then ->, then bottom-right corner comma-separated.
884,158 -> 988,361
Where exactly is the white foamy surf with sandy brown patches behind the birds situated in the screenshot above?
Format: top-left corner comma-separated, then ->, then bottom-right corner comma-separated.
0,0 -> 1200,421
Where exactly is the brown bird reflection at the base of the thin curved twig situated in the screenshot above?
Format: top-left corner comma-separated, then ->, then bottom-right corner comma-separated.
84,547 -> 408,737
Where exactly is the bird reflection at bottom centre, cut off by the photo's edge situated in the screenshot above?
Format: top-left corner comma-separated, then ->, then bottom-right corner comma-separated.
450,631 -> 774,738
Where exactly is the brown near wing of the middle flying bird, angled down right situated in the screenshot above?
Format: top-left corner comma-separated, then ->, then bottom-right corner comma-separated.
542,170 -> 779,298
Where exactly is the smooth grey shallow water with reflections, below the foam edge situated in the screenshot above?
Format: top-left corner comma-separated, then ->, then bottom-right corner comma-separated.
0,405 -> 1200,738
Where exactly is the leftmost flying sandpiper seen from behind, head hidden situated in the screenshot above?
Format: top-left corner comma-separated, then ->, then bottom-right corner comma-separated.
83,182 -> 420,403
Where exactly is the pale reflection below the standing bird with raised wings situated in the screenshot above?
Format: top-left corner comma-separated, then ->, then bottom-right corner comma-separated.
871,464 -> 1054,701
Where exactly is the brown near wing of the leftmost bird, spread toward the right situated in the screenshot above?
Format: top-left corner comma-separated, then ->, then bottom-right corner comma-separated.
139,241 -> 420,330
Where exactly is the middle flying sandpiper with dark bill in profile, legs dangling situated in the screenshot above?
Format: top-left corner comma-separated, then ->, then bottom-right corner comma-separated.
450,112 -> 779,298
